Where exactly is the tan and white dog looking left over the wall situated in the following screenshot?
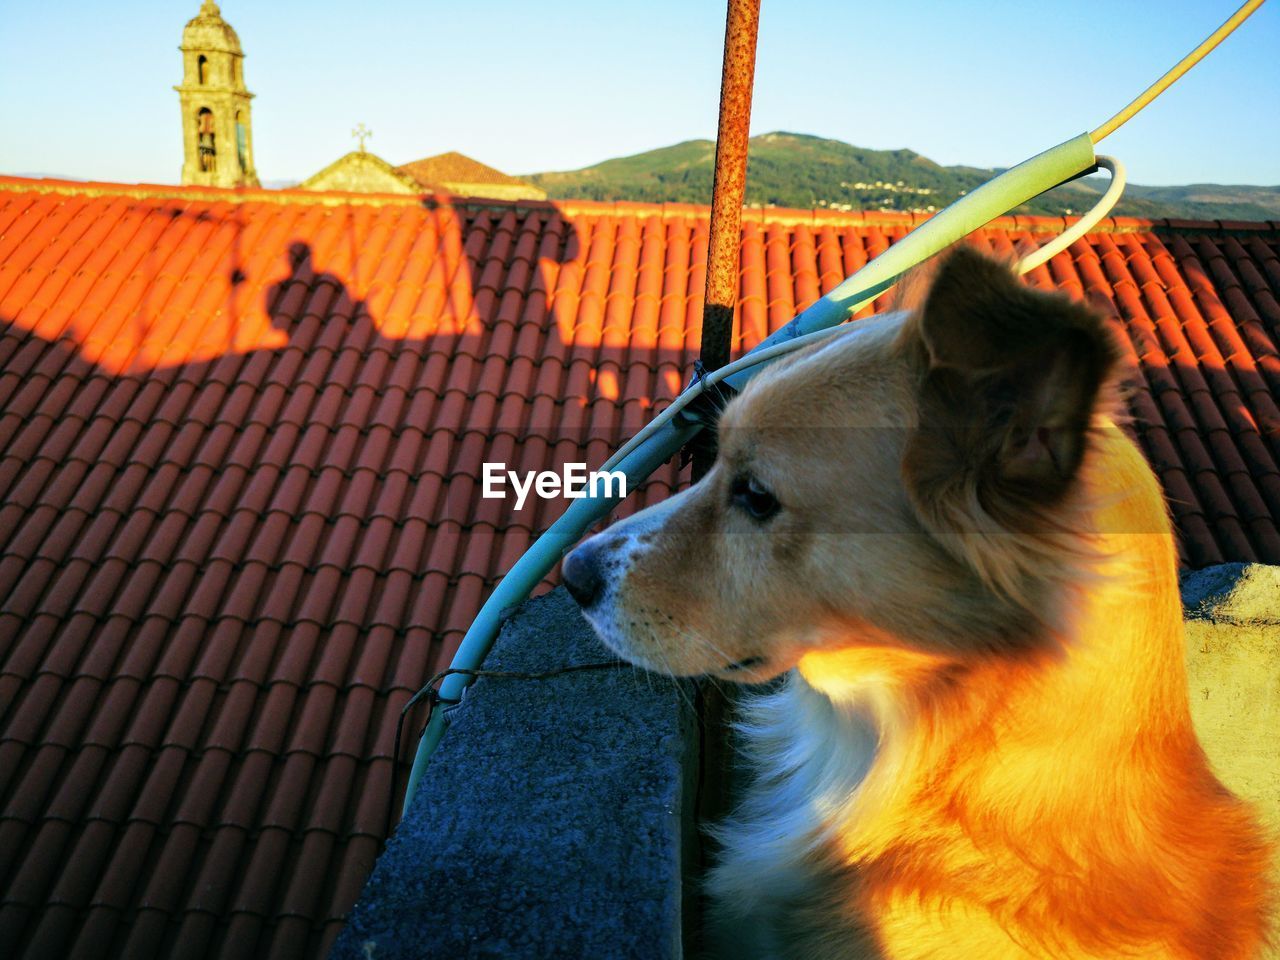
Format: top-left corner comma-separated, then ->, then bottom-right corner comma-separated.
563,247 -> 1272,960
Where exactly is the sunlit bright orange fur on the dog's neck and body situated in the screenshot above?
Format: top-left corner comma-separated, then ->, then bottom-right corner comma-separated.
800,434 -> 1268,960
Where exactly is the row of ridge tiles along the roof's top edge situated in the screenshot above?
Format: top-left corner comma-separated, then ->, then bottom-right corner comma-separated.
0,174 -> 1280,233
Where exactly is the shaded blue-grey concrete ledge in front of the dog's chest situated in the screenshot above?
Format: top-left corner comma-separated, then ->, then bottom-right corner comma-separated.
332,590 -> 692,960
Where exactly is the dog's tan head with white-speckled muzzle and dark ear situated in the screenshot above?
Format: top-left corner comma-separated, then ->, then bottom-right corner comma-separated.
563,248 -> 1117,681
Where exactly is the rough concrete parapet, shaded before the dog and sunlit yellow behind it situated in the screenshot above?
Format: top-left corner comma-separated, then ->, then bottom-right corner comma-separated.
333,564 -> 1280,960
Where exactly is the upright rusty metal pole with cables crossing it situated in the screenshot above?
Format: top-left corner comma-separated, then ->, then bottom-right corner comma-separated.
694,0 -> 760,480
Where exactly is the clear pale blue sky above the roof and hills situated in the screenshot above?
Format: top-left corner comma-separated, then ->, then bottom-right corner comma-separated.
0,0 -> 1280,184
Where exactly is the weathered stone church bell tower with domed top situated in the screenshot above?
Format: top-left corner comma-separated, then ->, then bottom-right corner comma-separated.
174,0 -> 259,187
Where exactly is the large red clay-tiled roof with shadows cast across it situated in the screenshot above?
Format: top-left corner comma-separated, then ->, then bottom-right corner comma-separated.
0,178 -> 1280,957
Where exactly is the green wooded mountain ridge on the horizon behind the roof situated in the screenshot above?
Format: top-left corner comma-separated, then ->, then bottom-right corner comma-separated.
524,133 -> 1280,220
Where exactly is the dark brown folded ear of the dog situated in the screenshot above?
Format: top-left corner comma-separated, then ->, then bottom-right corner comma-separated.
904,247 -> 1119,593
